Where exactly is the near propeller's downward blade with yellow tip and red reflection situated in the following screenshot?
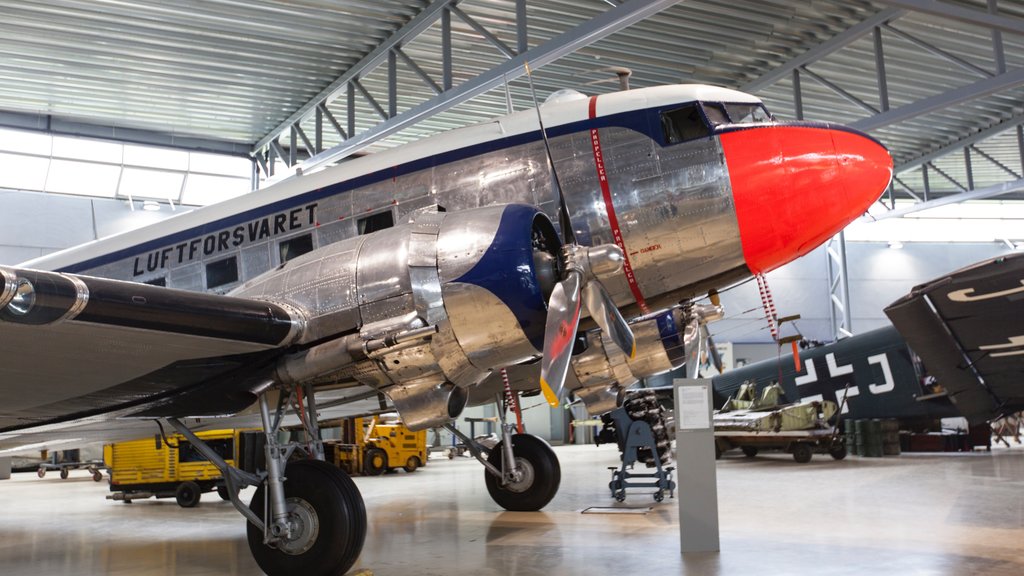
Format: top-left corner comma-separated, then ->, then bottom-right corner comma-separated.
541,272 -> 583,407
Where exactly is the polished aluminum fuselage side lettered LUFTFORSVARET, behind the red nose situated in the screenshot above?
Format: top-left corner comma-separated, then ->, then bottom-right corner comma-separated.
44,90 -> 750,314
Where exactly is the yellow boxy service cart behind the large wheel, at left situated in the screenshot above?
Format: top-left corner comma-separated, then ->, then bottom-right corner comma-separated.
103,429 -> 266,508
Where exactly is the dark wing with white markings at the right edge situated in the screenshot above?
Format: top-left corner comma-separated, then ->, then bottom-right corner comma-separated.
885,253 -> 1024,423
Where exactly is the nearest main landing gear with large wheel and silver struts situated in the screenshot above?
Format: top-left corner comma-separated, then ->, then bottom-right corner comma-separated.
168,382 -> 367,576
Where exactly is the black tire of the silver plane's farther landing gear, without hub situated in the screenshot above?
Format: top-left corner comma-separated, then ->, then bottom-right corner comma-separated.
483,434 -> 562,512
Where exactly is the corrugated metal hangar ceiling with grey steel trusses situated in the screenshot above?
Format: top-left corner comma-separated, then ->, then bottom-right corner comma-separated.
0,0 -> 1024,208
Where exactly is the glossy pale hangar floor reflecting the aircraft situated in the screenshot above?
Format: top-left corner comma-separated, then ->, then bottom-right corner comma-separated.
0,446 -> 1024,576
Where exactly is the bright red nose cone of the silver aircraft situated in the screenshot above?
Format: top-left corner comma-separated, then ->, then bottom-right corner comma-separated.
720,124 -> 893,274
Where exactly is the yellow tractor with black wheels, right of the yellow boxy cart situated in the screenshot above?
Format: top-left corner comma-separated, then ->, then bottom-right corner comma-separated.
321,415 -> 427,476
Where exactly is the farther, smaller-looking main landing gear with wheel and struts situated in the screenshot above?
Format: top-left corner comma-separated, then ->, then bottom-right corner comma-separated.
444,395 -> 562,511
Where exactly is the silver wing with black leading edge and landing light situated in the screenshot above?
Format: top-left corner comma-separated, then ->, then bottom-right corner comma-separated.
0,268 -> 301,448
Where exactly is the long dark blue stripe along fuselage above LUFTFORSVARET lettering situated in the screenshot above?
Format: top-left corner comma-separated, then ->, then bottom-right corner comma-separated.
57,105 -> 663,273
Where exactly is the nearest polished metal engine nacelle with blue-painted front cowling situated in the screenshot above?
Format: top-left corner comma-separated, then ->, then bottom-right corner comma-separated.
236,204 -> 560,429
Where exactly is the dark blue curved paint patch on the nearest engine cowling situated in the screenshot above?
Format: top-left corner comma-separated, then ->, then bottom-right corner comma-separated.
455,204 -> 548,351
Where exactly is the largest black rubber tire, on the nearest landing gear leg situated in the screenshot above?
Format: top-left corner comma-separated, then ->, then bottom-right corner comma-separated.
247,460 -> 367,576
